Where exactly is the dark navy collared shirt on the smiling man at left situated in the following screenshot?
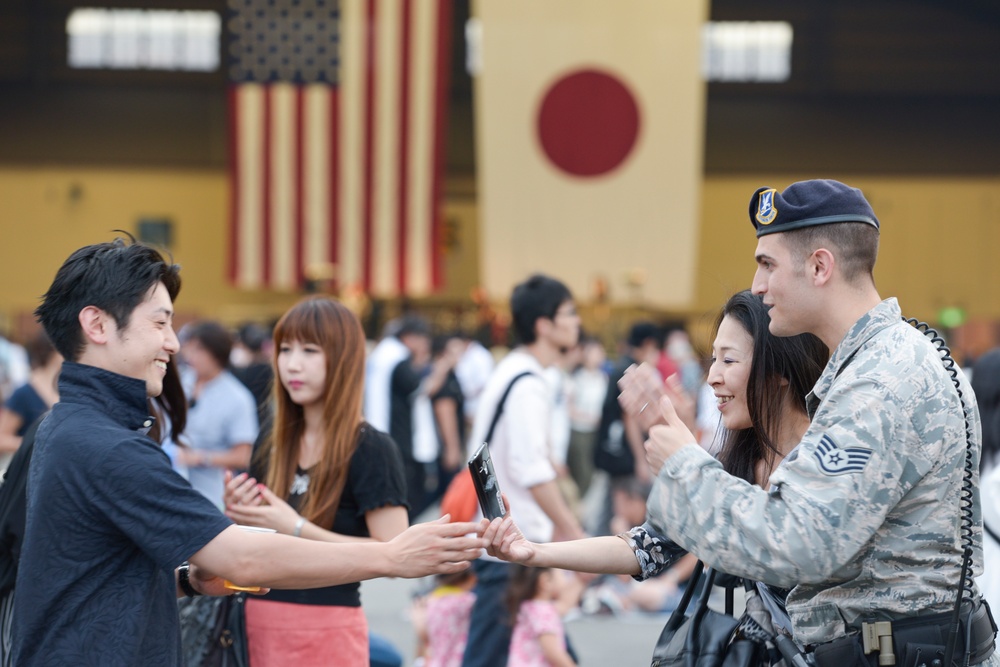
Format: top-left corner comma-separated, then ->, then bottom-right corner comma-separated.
14,362 -> 231,667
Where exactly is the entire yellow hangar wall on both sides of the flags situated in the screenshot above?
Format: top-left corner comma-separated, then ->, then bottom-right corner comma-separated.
0,168 -> 1000,344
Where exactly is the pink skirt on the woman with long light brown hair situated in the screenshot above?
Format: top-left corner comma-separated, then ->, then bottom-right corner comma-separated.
246,596 -> 368,667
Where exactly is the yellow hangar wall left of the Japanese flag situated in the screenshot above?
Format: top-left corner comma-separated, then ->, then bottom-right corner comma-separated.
0,167 -> 477,337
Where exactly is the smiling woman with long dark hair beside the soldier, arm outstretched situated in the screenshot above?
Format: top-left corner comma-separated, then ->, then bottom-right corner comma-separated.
476,290 -> 829,620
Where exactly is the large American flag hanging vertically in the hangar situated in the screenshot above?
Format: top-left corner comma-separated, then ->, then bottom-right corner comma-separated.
229,0 -> 452,296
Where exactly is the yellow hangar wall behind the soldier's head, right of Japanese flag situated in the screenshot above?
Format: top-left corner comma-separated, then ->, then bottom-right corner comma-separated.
696,174 -> 1000,323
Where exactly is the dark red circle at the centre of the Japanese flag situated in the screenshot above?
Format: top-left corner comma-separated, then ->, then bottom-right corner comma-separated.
538,69 -> 639,176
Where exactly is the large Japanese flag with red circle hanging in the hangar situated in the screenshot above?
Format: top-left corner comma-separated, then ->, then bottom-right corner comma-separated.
475,0 -> 708,307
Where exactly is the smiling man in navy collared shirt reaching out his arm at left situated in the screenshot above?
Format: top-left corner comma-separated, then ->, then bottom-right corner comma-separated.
13,239 -> 480,667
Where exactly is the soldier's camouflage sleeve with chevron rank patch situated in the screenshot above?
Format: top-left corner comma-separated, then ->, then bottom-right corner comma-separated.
649,374 -> 940,587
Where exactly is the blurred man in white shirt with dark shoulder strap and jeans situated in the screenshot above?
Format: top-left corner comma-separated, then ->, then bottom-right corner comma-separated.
462,275 -> 583,667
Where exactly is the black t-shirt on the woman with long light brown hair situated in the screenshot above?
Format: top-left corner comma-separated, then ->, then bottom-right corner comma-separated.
252,424 -> 407,607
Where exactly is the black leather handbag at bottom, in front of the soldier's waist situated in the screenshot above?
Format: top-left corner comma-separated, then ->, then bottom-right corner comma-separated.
651,561 -> 760,667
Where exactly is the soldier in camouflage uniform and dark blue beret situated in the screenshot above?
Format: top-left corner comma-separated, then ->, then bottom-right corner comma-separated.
644,181 -> 1000,665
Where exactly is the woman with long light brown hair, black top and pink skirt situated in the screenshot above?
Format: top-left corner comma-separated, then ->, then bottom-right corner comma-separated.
226,297 -> 408,667
